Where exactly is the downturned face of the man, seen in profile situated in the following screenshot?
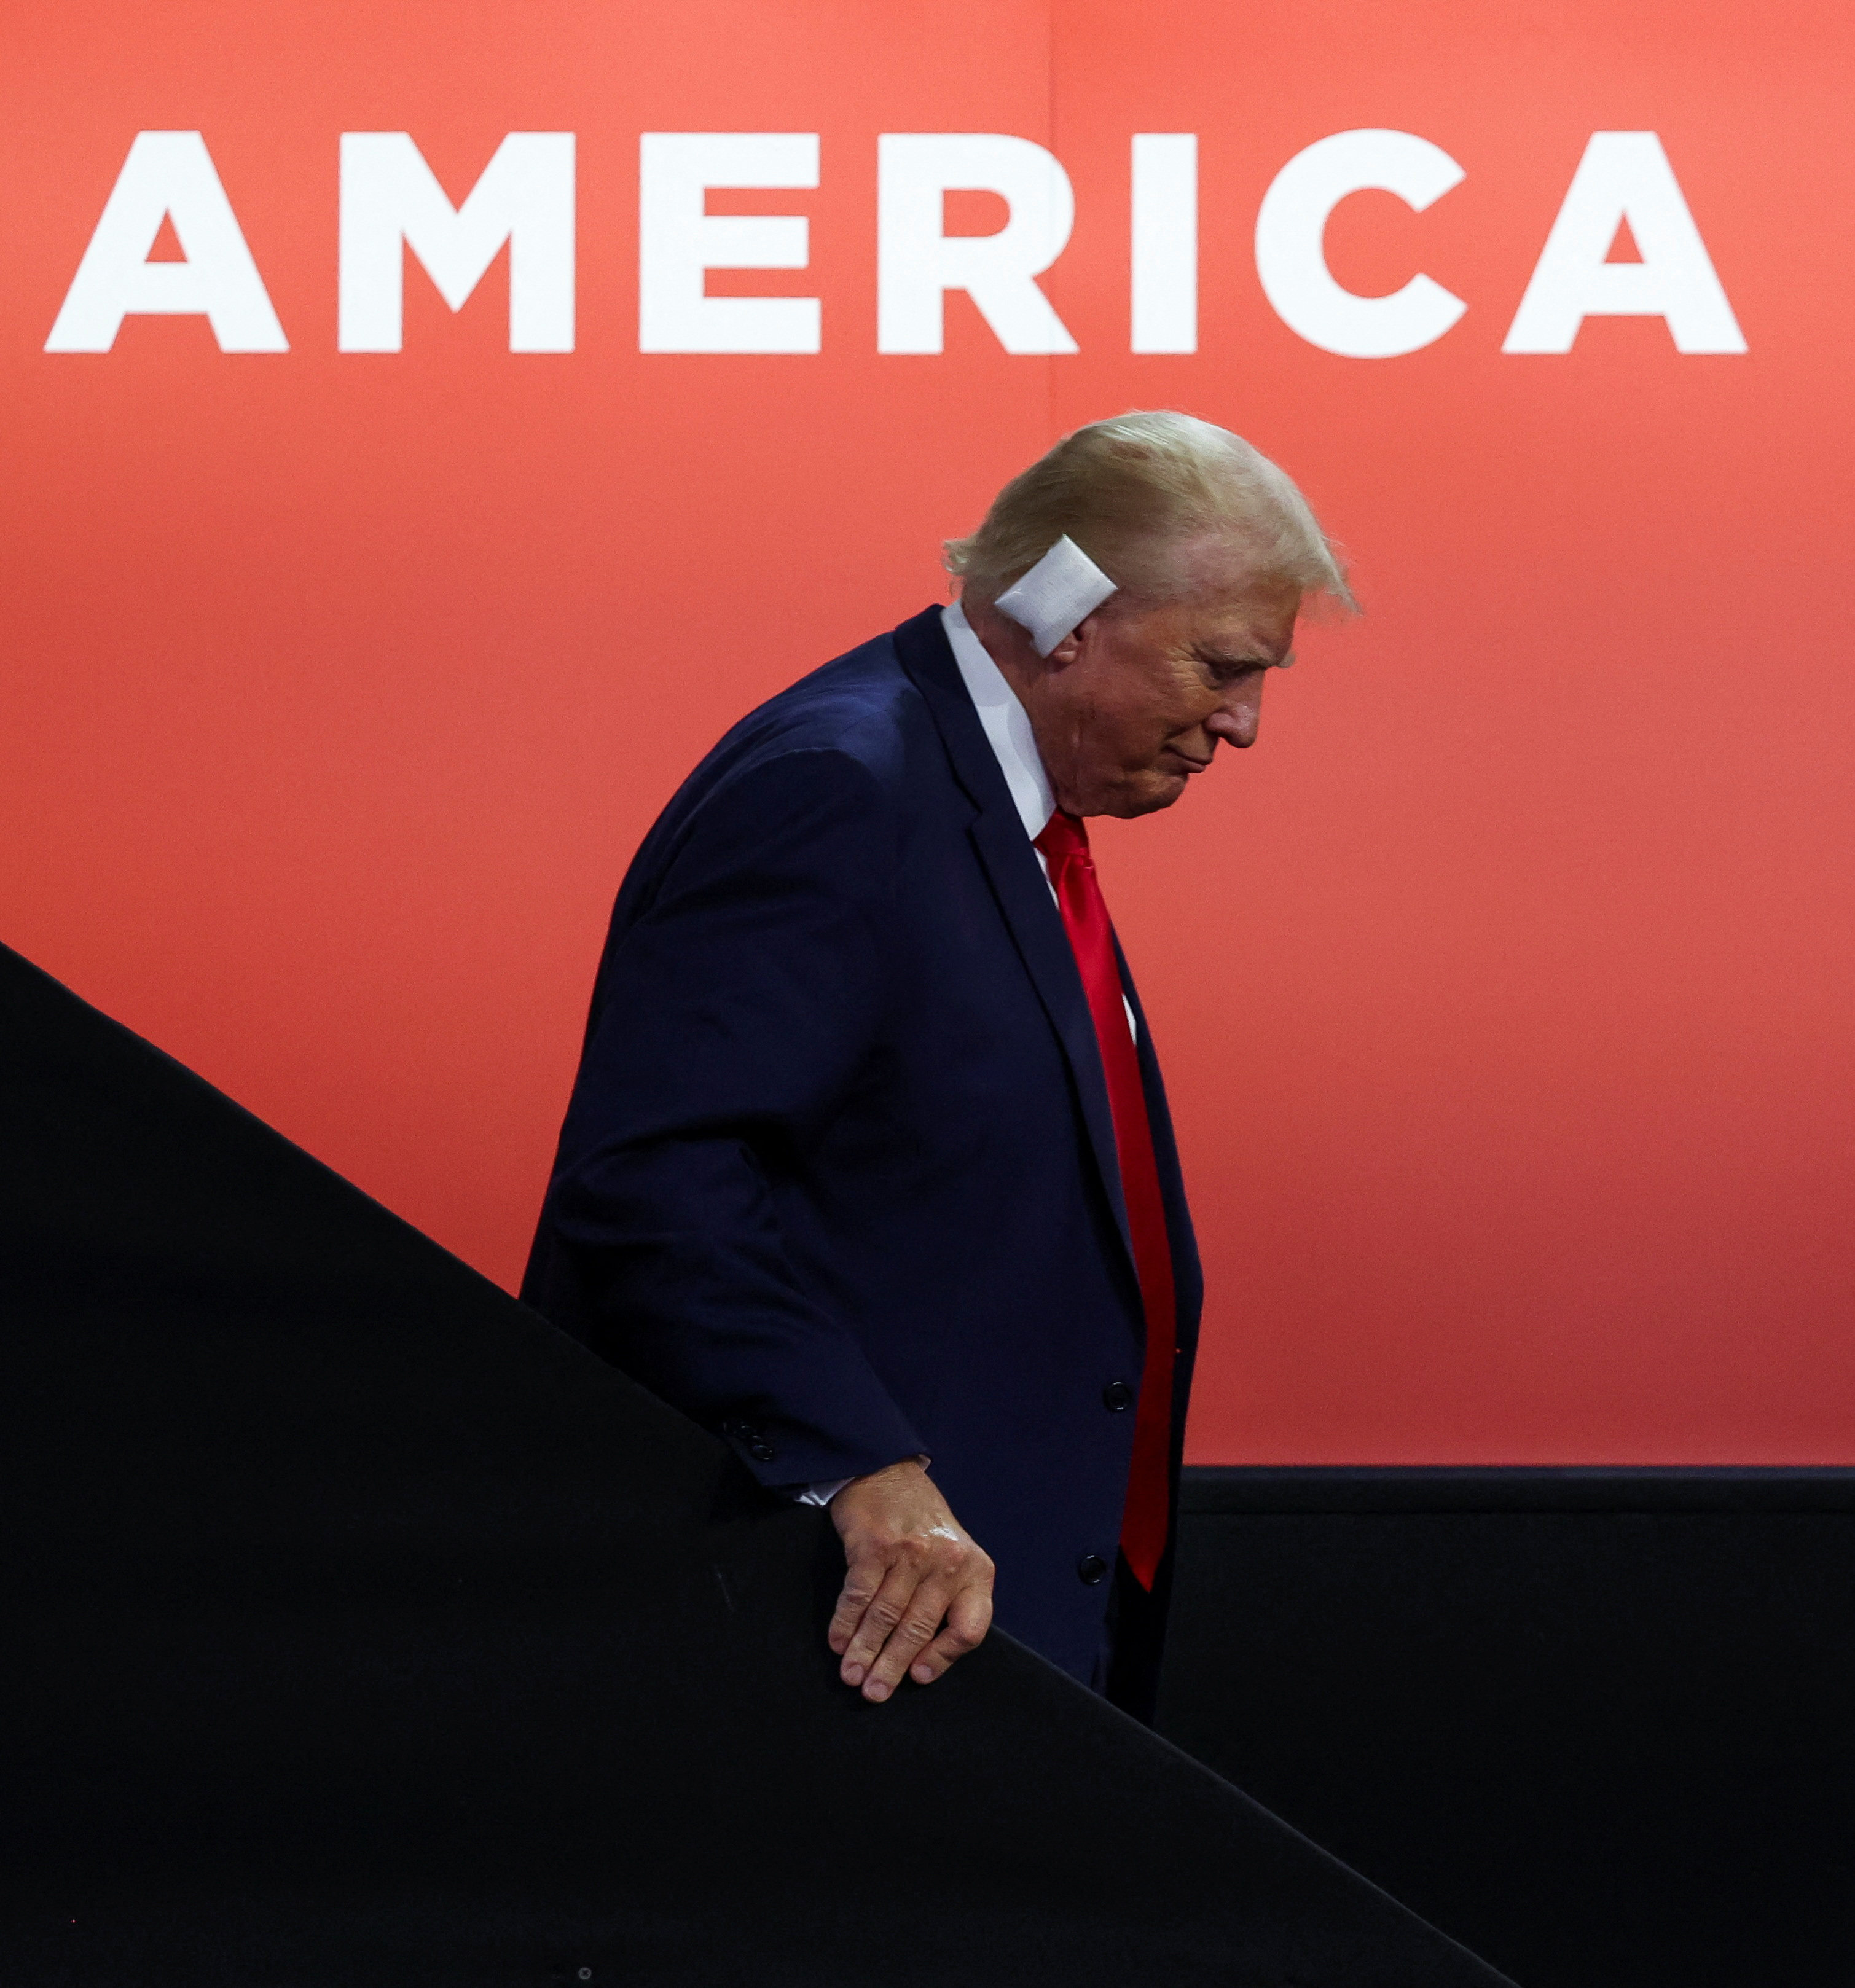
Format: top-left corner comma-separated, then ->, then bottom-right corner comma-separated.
1012,552 -> 1300,815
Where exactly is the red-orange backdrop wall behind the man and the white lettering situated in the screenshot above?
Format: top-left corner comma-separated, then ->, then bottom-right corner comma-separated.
0,0 -> 1855,1463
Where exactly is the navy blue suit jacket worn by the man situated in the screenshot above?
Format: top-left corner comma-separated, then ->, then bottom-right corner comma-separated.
523,608 -> 1201,1680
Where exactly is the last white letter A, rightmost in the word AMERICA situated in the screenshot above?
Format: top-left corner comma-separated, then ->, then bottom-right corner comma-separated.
1501,131 -> 1746,352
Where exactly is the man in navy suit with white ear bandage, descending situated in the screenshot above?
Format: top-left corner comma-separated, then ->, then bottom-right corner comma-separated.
523,413 -> 1348,1718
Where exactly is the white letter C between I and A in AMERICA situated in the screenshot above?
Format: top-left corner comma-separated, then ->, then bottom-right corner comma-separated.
1257,131 -> 1469,360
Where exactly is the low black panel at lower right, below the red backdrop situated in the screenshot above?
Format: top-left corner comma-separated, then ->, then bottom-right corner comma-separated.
1161,1469 -> 1855,1988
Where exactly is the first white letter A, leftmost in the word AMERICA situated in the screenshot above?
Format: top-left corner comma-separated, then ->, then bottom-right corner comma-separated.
45,131 -> 290,352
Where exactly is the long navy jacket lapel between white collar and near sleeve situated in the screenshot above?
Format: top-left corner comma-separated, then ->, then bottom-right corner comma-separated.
895,608 -> 1133,1272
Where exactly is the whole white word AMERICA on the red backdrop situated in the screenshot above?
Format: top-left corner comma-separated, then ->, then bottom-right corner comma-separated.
45,131 -> 1746,360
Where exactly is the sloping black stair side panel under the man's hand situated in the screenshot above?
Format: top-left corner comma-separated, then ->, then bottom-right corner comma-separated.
0,950 -> 1501,1988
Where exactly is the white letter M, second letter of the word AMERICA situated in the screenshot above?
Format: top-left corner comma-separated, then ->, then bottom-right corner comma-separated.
338,131 -> 573,352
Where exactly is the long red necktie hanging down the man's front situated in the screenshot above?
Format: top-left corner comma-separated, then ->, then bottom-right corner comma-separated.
1036,809 -> 1177,1589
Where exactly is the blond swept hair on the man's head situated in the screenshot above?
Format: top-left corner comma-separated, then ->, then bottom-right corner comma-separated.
944,412 -> 1356,608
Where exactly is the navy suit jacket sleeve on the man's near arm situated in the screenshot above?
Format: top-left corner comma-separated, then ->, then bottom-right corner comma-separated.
551,749 -> 925,1485
